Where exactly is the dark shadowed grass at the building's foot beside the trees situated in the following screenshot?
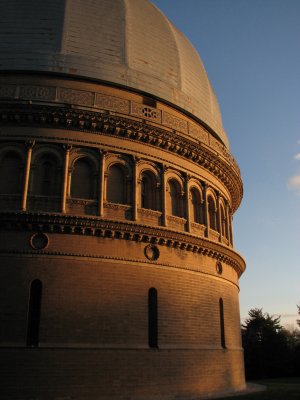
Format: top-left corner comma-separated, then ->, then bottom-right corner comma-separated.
220,378 -> 300,400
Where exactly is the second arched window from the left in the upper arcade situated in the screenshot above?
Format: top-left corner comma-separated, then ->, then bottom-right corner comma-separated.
32,155 -> 61,196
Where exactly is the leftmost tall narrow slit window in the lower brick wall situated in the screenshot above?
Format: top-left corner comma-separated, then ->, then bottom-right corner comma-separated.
27,279 -> 42,347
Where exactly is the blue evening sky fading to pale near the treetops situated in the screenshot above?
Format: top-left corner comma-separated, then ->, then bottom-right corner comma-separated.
152,0 -> 300,329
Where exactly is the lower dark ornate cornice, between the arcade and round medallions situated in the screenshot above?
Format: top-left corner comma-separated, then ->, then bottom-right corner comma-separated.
0,212 -> 245,276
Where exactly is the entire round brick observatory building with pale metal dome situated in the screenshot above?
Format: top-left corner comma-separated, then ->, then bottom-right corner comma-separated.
0,0 -> 245,400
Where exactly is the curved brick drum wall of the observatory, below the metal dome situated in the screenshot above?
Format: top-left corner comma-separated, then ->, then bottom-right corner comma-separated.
0,75 -> 244,399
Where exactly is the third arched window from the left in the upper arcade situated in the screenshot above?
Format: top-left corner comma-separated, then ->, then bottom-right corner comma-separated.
71,157 -> 97,199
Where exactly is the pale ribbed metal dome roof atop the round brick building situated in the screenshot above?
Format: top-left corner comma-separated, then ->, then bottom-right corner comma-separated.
0,0 -> 229,147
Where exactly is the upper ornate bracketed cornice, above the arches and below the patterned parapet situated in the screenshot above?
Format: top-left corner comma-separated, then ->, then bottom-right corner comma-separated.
0,103 -> 243,212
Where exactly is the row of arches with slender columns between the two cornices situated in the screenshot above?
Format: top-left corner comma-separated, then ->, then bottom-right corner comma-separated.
0,143 -> 232,246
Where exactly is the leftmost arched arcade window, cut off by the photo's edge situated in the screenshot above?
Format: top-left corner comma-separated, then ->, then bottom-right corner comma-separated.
0,153 -> 23,194
